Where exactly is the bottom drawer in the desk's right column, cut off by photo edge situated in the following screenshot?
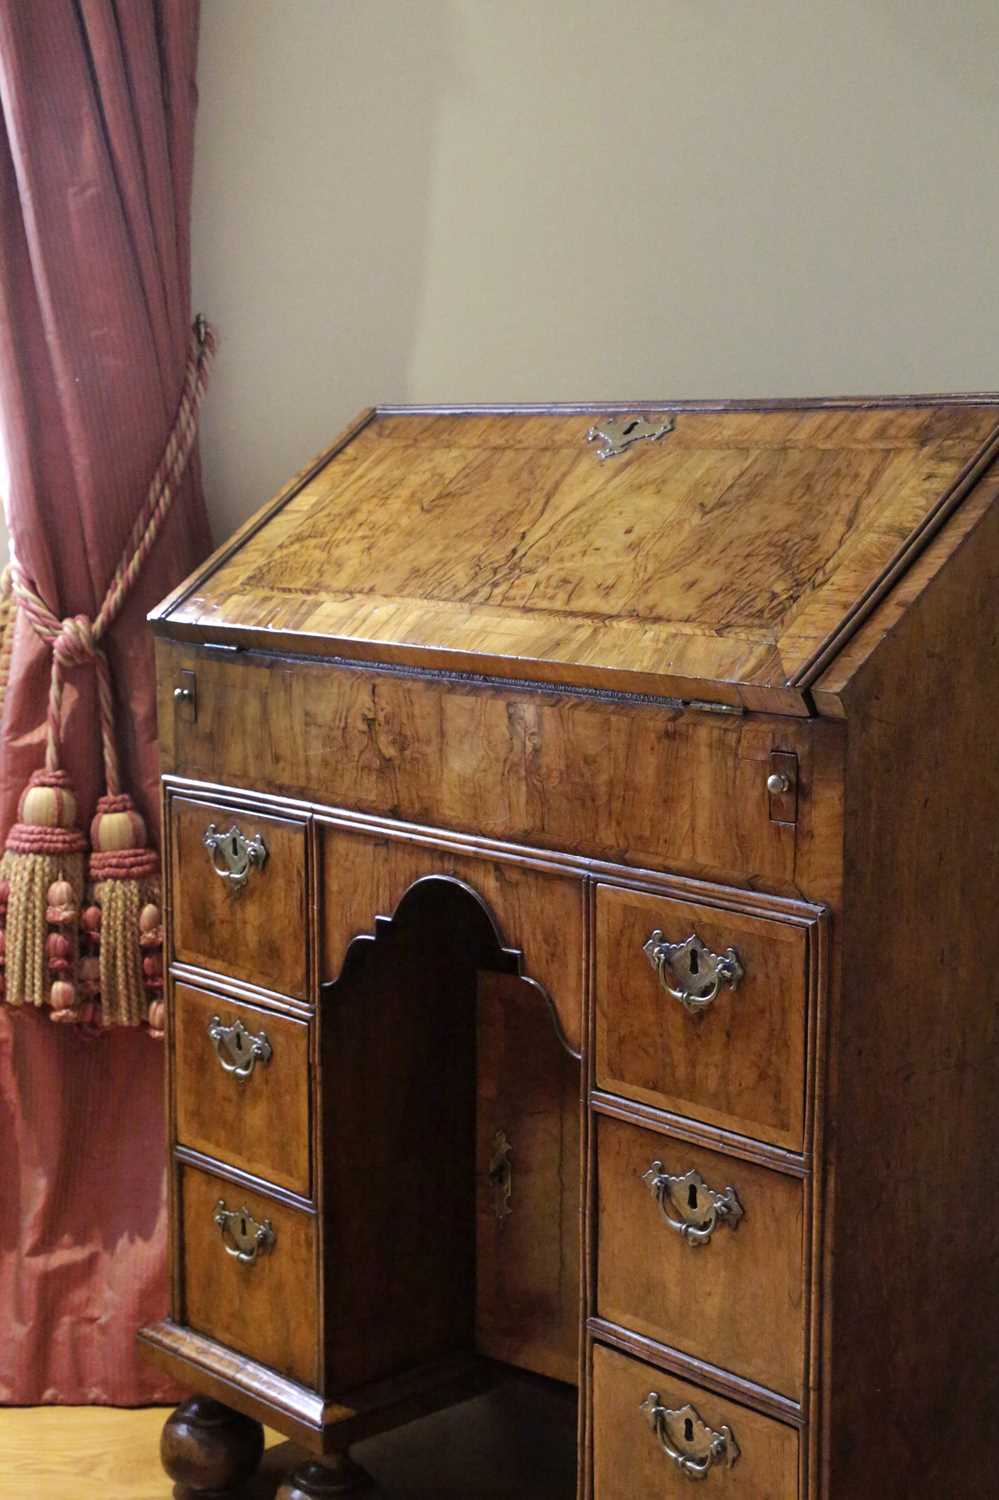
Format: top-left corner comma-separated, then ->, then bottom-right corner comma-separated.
593,1344 -> 800,1500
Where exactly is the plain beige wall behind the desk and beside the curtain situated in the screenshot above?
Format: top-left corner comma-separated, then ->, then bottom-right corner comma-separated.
194,0 -> 999,534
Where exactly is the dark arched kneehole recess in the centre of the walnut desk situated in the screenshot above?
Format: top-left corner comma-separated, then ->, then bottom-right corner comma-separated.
323,876 -> 581,1466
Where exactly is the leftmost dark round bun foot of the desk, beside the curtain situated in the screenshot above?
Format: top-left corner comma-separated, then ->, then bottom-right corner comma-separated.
159,1397 -> 264,1497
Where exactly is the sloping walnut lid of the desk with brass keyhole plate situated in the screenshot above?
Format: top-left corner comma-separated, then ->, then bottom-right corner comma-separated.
150,395 -> 999,717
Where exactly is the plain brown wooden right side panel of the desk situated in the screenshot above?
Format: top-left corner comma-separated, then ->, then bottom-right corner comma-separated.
821,489 -> 999,1500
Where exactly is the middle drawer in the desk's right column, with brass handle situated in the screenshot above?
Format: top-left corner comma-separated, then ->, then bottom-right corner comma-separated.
597,1116 -> 806,1401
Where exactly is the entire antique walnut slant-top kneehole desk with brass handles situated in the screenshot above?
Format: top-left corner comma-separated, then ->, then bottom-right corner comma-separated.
141,396 -> 999,1500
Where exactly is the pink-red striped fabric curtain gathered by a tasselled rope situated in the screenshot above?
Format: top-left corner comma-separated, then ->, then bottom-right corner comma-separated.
0,0 -> 209,1404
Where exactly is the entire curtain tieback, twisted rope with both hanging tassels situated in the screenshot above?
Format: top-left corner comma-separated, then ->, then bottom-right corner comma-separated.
0,318 -> 216,1037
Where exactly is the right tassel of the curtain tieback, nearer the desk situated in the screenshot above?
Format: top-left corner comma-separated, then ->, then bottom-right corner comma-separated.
87,794 -> 162,1035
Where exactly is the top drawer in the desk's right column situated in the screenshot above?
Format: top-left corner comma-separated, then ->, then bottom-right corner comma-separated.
596,885 -> 809,1151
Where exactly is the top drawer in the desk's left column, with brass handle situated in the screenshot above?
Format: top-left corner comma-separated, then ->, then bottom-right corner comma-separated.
170,797 -> 308,999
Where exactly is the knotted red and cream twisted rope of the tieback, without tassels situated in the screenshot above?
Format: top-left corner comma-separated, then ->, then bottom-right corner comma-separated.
7,318 -> 216,797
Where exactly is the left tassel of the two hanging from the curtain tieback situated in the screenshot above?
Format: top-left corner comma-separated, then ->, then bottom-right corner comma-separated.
0,771 -> 87,1011
